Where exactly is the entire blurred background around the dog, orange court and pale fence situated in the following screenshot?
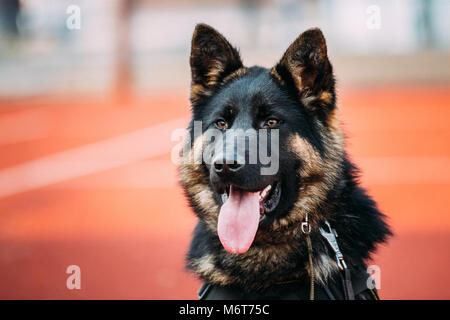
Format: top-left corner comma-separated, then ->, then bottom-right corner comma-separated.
0,0 -> 450,299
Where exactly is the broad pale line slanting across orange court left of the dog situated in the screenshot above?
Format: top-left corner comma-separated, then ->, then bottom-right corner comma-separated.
0,118 -> 188,197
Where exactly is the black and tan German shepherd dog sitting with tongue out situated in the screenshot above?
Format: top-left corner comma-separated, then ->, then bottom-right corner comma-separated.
179,24 -> 391,299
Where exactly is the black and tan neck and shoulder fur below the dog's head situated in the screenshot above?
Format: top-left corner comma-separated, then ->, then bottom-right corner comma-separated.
187,163 -> 390,290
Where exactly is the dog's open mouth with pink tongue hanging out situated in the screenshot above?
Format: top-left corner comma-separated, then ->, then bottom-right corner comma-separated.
217,182 -> 281,253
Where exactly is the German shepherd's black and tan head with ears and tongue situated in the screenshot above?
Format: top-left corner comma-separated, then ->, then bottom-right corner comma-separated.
180,24 -> 344,253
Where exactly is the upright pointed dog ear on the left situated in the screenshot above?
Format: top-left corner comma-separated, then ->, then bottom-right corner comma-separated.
190,24 -> 243,103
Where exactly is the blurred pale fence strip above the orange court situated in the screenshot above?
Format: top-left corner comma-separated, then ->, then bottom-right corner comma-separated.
0,0 -> 450,96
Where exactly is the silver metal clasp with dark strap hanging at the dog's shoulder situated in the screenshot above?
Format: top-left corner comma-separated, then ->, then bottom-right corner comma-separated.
319,221 -> 355,300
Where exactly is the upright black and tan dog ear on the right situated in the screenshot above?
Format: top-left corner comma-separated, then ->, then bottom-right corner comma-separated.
271,28 -> 335,115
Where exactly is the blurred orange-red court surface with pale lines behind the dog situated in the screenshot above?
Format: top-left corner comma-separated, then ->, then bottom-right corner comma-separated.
0,85 -> 450,299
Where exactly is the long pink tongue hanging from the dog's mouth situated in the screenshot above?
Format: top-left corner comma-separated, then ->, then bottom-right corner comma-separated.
217,186 -> 260,253
